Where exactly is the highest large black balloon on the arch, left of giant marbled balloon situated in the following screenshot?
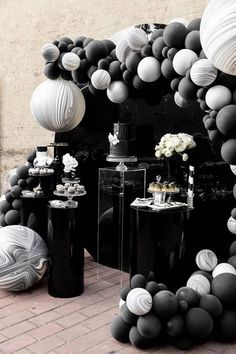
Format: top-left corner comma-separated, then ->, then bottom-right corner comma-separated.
163,22 -> 187,48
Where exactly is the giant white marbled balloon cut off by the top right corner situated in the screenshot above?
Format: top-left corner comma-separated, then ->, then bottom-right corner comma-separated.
200,0 -> 236,75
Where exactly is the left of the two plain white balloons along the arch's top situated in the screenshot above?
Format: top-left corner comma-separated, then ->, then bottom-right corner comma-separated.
137,57 -> 161,82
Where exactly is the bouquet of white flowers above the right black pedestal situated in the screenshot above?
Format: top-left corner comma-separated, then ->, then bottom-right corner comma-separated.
155,133 -> 196,161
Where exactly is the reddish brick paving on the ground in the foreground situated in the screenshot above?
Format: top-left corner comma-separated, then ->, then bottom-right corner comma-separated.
0,252 -> 236,354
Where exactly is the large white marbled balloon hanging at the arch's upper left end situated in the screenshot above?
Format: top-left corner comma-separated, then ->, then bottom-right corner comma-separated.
31,78 -> 85,132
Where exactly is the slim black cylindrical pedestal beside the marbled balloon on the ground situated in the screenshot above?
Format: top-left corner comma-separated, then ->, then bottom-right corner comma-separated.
48,206 -> 84,298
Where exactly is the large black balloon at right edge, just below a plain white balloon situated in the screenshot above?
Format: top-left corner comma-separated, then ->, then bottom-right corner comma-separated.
216,104 -> 236,136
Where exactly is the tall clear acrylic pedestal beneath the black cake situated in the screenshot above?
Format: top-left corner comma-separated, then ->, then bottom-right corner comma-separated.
97,167 -> 146,285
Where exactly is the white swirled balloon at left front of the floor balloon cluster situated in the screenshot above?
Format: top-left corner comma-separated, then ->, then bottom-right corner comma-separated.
126,288 -> 152,316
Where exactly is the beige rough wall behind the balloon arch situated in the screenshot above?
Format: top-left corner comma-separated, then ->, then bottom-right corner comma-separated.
0,0 -> 207,194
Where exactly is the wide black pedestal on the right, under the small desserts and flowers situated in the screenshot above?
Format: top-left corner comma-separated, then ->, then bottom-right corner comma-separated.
130,207 -> 186,289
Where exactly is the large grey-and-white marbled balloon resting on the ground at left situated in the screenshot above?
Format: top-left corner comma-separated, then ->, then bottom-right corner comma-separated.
0,225 -> 48,291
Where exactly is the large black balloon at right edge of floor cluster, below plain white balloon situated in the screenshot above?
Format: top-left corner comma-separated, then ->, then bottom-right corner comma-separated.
211,273 -> 236,307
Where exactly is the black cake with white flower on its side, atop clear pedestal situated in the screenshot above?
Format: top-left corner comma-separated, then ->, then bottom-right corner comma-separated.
108,122 -> 131,158
